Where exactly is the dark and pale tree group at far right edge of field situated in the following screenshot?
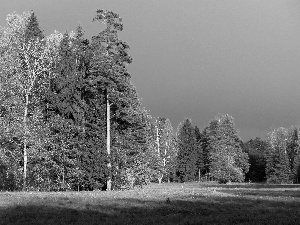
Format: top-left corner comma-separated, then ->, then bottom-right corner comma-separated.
243,126 -> 300,184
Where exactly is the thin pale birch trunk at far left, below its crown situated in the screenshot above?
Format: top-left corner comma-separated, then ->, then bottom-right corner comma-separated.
23,94 -> 29,191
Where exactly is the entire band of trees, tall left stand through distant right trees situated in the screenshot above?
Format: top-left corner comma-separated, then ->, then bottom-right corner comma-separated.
0,10 -> 300,191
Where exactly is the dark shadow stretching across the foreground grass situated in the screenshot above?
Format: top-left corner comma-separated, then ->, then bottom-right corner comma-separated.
0,195 -> 300,225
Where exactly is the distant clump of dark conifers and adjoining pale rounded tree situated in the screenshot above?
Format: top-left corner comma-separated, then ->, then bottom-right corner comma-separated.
176,115 -> 249,183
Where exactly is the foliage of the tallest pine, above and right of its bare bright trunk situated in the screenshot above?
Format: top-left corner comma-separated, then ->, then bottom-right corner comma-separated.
87,10 -> 148,190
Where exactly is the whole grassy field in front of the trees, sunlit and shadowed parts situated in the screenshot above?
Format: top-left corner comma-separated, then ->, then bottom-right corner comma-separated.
0,183 -> 300,225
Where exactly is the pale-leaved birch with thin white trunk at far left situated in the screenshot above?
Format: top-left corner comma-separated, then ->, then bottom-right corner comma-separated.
0,13 -> 57,190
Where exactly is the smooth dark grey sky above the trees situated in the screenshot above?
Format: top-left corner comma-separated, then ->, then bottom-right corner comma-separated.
0,0 -> 300,141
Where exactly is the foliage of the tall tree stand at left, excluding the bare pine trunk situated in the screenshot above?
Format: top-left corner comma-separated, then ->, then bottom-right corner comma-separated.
0,10 -> 150,190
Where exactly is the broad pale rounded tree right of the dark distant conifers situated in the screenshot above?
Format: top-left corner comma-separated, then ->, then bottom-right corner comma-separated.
203,115 -> 249,183
